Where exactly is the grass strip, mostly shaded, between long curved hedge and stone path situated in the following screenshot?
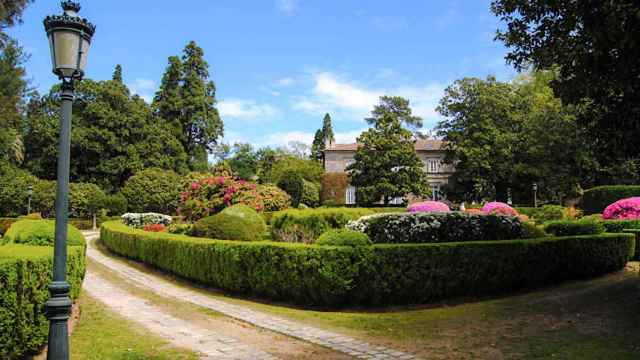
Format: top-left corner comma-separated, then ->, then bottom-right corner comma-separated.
94,235 -> 640,360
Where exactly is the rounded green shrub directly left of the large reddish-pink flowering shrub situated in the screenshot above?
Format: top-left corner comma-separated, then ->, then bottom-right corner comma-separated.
122,168 -> 182,214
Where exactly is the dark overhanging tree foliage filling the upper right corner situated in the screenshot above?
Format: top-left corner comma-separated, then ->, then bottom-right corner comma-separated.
492,0 -> 640,179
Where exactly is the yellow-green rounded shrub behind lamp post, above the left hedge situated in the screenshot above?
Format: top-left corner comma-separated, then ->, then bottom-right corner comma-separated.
0,220 -> 85,246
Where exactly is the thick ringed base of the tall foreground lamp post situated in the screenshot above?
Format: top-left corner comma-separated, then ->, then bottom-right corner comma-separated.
45,281 -> 73,360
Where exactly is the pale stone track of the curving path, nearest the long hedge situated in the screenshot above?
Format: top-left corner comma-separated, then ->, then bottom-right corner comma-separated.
84,232 -> 418,360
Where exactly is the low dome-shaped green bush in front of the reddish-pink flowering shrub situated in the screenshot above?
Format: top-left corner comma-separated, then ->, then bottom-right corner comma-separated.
191,205 -> 266,241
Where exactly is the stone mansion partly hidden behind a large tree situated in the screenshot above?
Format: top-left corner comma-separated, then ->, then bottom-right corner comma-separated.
324,140 -> 454,204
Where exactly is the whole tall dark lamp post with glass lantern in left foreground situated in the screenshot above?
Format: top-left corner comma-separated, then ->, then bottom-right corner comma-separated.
44,1 -> 95,360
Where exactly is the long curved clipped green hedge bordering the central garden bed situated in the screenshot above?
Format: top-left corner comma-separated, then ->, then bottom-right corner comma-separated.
101,222 -> 635,307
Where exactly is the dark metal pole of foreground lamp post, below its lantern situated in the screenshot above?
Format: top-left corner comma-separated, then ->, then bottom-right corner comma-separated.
46,81 -> 74,360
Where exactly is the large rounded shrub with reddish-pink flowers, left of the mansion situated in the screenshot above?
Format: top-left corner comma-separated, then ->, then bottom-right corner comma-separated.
178,176 -> 264,221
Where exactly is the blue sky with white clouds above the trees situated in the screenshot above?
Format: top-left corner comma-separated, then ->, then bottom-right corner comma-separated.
11,0 -> 515,146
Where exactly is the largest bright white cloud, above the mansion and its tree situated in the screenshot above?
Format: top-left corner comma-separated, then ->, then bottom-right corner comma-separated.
292,72 -> 445,127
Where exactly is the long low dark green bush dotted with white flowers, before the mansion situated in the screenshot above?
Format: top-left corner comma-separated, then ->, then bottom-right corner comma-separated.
348,212 -> 522,244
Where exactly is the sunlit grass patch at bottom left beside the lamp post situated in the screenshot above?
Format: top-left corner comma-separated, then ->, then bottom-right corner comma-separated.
70,294 -> 198,360
